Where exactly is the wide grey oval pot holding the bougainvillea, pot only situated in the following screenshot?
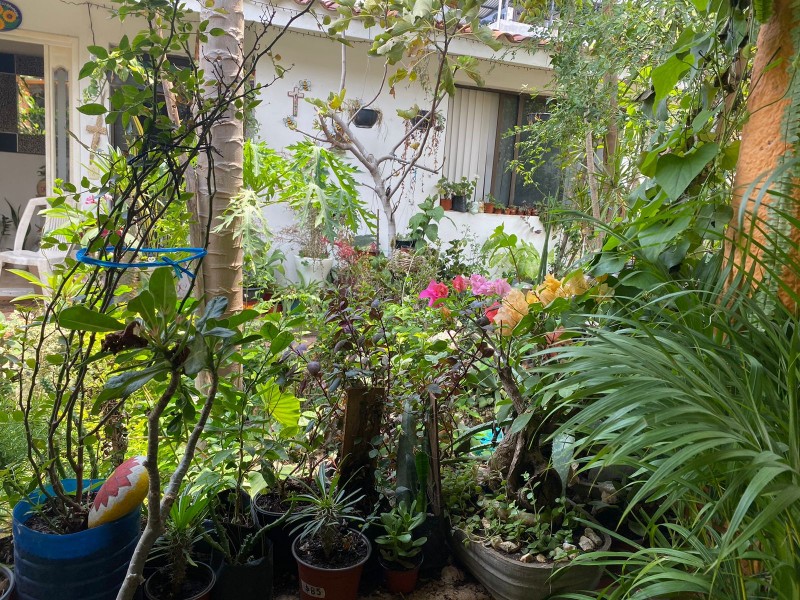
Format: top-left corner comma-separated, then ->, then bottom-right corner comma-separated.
450,529 -> 611,600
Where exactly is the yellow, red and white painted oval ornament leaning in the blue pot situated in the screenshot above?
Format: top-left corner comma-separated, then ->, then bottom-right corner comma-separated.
89,456 -> 149,528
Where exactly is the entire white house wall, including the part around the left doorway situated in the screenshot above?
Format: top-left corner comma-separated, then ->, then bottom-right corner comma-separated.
3,0 -> 550,282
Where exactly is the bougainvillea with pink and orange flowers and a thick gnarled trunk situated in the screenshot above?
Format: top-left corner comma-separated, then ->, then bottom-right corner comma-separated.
419,271 -> 605,510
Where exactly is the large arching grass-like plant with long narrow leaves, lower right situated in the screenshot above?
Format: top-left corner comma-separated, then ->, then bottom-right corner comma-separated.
546,186 -> 800,600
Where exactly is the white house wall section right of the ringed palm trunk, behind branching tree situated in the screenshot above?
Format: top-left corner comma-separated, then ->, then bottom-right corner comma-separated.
256,22 -> 550,279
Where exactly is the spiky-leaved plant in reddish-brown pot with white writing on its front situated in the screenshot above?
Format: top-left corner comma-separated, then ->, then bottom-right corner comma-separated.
291,463 -> 372,600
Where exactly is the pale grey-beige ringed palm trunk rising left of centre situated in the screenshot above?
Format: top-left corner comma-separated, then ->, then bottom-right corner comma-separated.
192,0 -> 244,312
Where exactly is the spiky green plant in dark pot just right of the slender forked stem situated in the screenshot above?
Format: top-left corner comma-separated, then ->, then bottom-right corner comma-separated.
144,490 -> 216,600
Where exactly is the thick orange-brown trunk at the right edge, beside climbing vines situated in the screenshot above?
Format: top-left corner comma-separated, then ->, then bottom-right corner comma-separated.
730,0 -> 800,307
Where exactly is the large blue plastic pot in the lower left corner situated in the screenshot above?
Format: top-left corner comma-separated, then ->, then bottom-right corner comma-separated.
13,479 -> 141,600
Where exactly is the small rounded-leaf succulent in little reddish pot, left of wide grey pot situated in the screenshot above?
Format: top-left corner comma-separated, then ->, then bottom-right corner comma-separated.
375,500 -> 428,594
